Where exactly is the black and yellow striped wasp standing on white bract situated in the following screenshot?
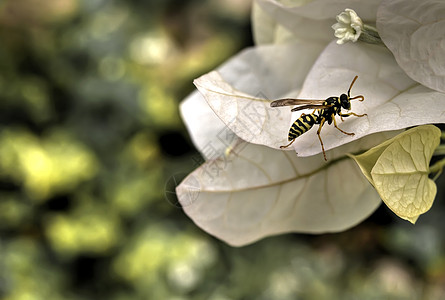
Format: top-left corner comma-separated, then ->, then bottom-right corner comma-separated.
270,76 -> 366,160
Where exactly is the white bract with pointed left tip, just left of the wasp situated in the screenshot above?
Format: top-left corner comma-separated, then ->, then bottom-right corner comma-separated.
195,42 -> 322,148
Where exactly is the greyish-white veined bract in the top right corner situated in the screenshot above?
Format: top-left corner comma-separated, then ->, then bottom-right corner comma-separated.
377,0 -> 445,92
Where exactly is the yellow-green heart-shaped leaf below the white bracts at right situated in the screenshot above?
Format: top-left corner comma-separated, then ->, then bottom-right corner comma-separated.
351,125 -> 441,224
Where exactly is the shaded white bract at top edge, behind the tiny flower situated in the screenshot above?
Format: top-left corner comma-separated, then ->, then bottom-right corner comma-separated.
254,0 -> 381,44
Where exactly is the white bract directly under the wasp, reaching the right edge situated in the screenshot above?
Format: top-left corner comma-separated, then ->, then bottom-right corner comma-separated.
292,42 -> 445,156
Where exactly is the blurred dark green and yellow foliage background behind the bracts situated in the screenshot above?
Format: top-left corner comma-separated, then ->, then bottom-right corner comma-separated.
0,0 -> 445,300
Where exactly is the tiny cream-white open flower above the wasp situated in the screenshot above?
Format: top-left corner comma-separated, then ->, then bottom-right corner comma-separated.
332,8 -> 363,44
